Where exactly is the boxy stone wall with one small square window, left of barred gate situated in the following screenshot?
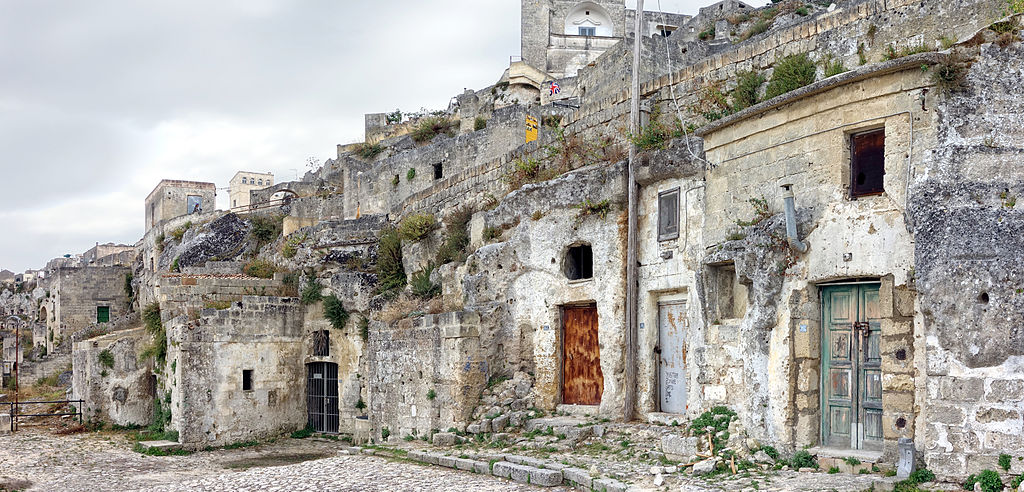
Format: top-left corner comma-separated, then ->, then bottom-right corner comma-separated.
164,295 -> 306,448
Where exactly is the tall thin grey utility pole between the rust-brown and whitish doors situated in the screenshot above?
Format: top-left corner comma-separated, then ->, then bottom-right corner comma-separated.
623,0 -> 643,421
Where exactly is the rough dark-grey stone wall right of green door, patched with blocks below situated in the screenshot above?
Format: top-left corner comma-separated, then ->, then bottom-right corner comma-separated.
907,42 -> 1024,477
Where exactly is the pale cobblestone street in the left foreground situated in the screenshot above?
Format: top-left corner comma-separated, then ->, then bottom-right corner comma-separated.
0,428 -> 565,492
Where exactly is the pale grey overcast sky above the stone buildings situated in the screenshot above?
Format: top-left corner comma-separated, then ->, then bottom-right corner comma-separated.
0,0 -> 763,272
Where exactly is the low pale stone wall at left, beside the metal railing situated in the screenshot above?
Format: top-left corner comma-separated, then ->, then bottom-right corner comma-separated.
72,328 -> 157,425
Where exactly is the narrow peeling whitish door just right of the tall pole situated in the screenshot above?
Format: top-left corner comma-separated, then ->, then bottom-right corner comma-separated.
657,300 -> 686,413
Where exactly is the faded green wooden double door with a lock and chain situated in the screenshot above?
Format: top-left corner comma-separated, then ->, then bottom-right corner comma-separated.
821,284 -> 882,450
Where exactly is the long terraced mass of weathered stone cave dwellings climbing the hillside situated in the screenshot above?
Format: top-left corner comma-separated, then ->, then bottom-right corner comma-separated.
66,0 -> 1024,478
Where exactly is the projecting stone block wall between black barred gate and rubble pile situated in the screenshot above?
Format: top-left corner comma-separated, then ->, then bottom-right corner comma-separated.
367,312 -> 489,441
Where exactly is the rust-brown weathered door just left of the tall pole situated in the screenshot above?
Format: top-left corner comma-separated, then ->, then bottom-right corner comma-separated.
562,305 -> 604,405
